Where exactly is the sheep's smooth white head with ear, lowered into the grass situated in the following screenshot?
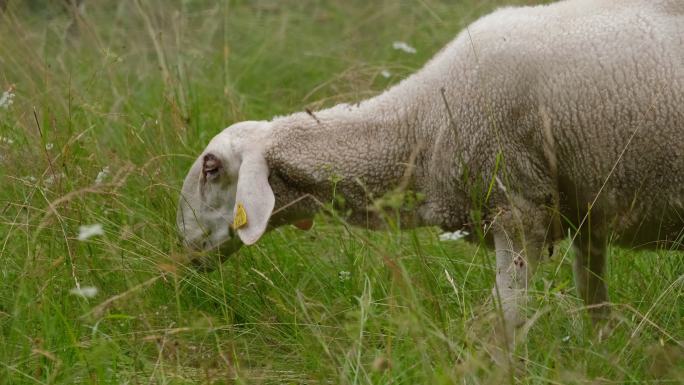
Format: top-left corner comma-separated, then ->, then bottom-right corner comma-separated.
177,121 -> 275,267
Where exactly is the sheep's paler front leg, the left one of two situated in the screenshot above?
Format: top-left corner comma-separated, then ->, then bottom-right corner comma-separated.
494,230 -> 541,346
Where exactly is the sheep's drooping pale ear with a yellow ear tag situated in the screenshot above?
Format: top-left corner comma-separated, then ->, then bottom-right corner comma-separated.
233,155 -> 275,245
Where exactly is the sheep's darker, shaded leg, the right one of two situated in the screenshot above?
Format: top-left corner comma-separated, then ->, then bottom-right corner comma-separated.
574,231 -> 609,322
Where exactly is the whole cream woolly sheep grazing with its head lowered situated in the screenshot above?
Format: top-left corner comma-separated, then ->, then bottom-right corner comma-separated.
177,0 -> 684,339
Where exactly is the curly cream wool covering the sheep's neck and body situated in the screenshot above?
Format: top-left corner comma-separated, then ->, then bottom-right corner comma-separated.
266,0 -> 684,245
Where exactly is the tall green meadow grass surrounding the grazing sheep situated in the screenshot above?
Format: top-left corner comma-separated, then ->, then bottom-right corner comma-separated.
0,0 -> 684,384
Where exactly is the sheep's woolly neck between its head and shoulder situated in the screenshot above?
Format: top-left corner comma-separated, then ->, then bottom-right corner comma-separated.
267,100 -> 425,227
